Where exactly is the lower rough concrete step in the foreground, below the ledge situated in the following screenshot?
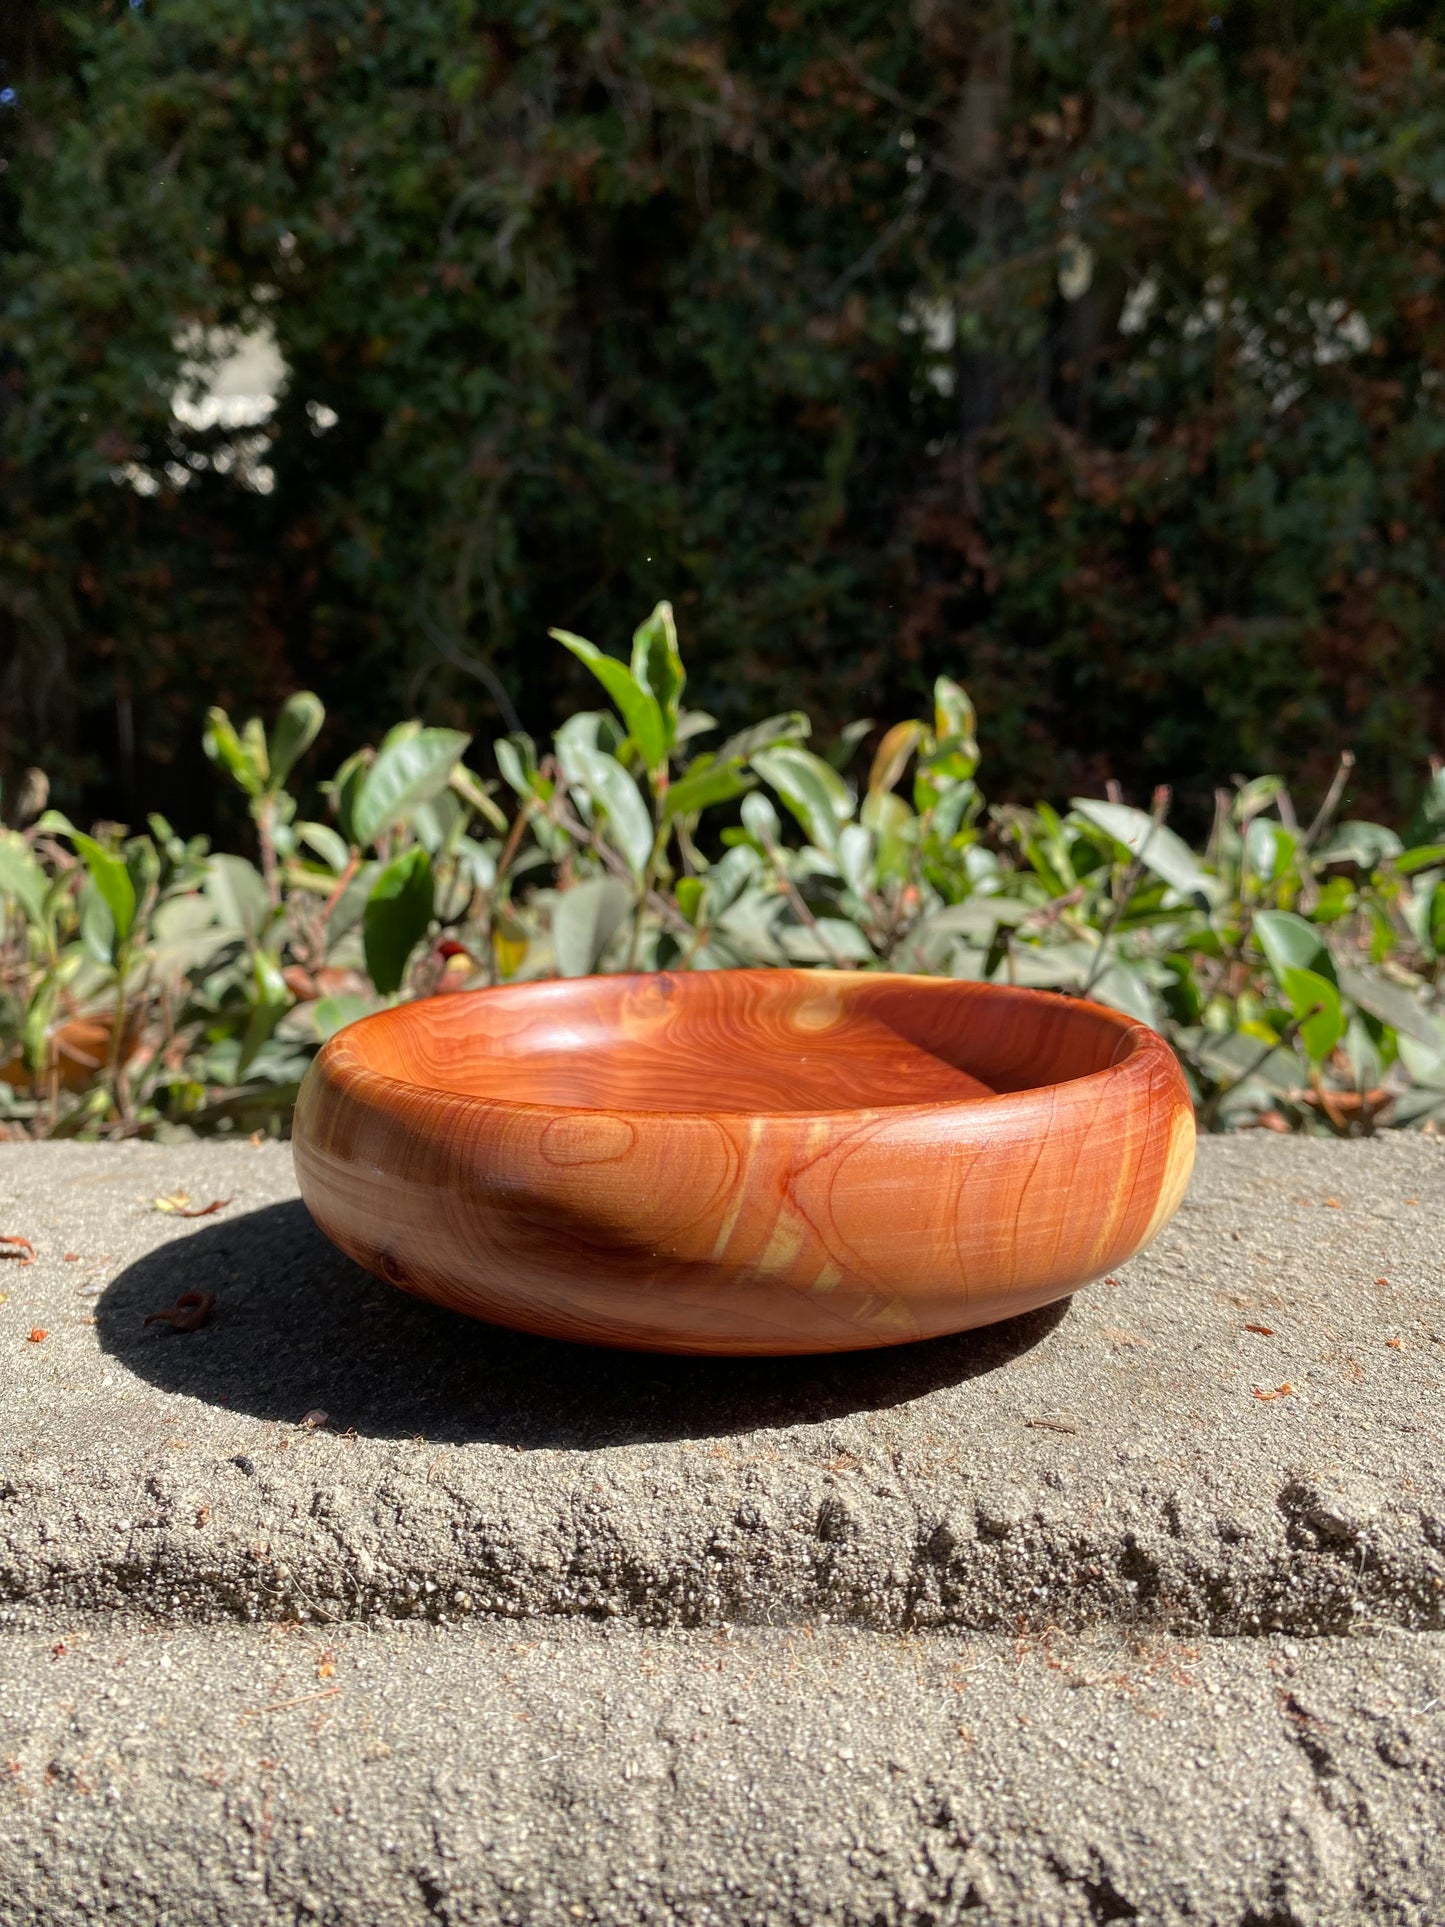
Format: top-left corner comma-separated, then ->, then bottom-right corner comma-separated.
0,1621 -> 1445,1927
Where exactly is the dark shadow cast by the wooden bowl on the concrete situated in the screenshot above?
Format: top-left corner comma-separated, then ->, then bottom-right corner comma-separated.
96,1201 -> 1069,1449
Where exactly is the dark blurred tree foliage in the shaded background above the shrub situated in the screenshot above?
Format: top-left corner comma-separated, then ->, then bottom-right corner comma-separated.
0,0 -> 1445,819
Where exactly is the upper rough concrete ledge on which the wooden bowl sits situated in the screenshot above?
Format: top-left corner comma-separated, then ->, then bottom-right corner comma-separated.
0,1135 -> 1445,1636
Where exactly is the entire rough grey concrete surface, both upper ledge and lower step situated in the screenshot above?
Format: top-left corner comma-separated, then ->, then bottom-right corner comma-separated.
0,1135 -> 1445,1927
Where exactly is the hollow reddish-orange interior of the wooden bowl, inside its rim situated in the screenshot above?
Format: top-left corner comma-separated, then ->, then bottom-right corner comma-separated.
347,971 -> 1131,1114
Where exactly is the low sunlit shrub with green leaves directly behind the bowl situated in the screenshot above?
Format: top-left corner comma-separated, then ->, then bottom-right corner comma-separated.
0,603 -> 1445,1135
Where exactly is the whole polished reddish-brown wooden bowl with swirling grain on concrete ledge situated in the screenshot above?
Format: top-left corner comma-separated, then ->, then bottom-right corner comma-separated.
295,971 -> 1195,1353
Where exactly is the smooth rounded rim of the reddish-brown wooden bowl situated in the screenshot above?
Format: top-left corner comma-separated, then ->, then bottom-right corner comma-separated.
308,967 -> 1177,1129
